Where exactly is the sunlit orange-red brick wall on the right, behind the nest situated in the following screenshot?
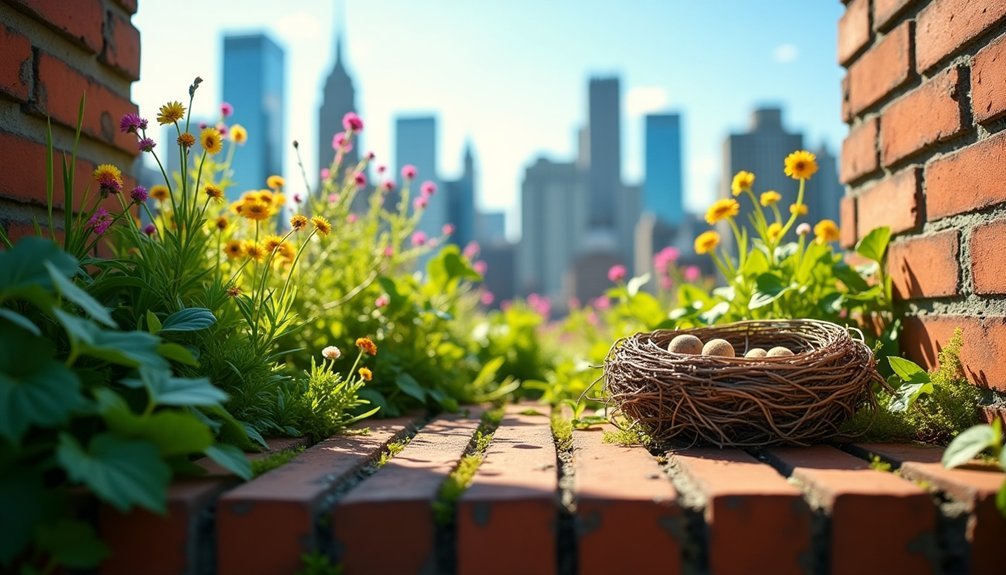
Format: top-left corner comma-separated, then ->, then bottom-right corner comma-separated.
838,0 -> 1006,397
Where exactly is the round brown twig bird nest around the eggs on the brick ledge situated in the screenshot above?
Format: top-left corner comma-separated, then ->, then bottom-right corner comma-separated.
604,320 -> 883,447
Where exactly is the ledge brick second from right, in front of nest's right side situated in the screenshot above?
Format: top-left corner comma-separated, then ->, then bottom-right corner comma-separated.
769,445 -> 939,575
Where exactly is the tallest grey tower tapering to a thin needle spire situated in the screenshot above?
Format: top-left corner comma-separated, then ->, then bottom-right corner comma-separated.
318,12 -> 360,188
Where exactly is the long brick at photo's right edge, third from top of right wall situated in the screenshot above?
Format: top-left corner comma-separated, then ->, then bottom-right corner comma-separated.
926,133 -> 1006,221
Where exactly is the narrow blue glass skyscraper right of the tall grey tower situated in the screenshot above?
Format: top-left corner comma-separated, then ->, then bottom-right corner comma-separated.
643,114 -> 685,226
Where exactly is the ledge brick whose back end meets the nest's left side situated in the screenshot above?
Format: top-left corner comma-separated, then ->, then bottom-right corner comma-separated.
573,428 -> 683,575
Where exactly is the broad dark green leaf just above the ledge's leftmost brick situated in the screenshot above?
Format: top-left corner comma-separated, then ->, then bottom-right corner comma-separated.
56,433 -> 171,514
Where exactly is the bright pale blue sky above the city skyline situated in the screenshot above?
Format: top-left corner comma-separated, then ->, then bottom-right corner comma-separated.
133,0 -> 846,237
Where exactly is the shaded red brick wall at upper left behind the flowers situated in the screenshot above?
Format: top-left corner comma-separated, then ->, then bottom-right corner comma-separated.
0,0 -> 140,242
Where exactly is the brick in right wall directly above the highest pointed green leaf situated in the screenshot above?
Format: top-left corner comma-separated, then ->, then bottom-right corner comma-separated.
856,166 -> 923,237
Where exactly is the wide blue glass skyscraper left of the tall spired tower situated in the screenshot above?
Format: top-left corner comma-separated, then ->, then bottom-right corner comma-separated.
223,33 -> 287,200
